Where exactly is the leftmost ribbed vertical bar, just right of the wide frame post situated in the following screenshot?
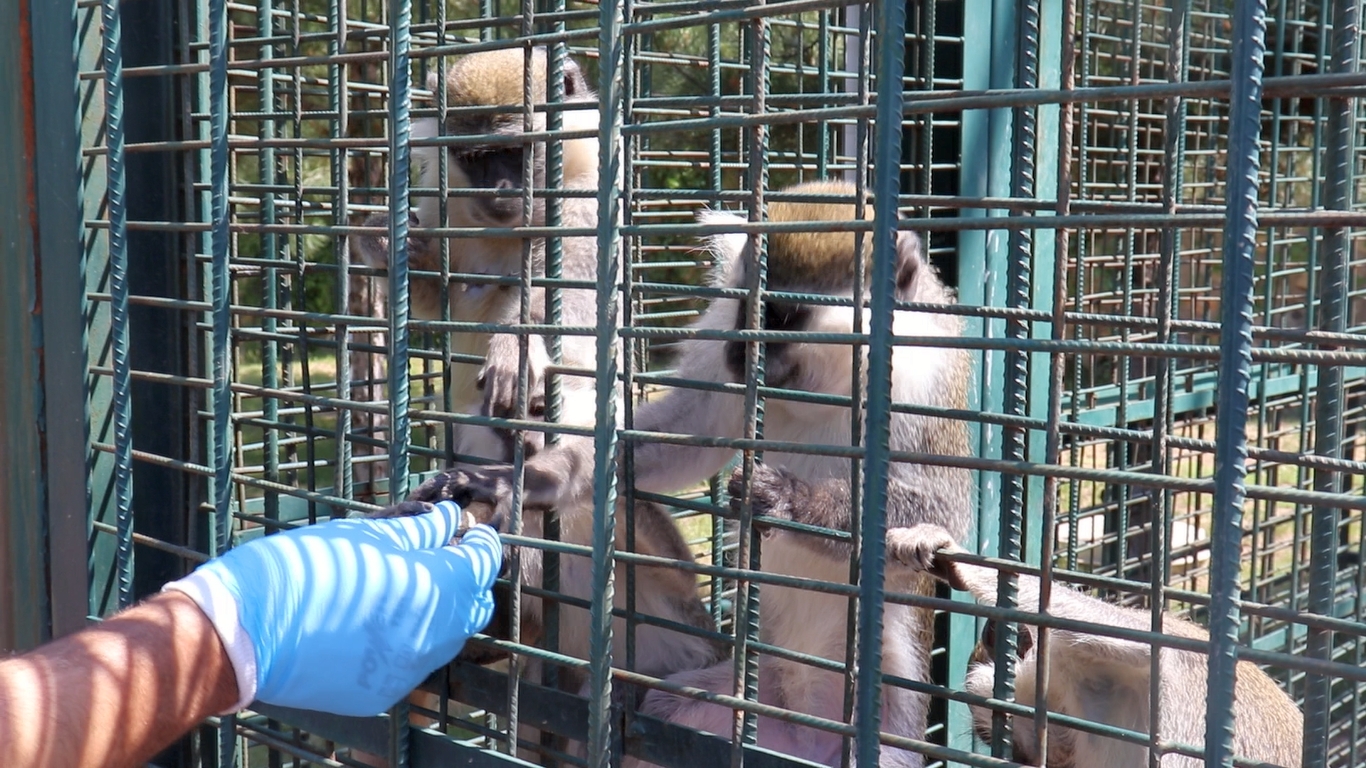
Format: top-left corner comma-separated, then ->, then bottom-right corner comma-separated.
102,0 -> 133,608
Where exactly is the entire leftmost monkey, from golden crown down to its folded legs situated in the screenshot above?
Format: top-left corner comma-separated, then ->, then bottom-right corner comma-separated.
346,48 -> 725,754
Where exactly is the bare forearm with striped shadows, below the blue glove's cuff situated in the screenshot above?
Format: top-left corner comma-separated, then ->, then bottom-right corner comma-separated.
0,592 -> 238,767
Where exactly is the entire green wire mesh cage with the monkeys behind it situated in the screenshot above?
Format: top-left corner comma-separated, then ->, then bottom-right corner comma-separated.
76,0 -> 1366,765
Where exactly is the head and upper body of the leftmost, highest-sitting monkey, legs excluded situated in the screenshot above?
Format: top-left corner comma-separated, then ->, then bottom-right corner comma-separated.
351,48 -> 598,461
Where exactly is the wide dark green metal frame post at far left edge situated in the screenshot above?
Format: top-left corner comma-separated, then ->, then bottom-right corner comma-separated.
0,3 -> 89,649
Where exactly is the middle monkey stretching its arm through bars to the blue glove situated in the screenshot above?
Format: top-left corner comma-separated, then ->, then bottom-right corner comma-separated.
414,180 -> 973,767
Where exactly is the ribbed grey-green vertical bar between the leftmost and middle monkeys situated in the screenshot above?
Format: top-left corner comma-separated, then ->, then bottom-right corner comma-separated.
589,3 -> 626,754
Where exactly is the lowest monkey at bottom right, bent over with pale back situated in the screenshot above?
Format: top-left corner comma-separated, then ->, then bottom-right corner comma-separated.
887,525 -> 1305,768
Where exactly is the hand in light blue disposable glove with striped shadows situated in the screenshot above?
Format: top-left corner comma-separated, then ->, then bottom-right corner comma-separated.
165,502 -> 503,715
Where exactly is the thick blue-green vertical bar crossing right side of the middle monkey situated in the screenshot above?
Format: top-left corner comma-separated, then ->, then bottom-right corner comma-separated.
854,1 -> 906,765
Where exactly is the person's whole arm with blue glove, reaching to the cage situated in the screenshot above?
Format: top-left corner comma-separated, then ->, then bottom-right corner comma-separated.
0,504 -> 503,768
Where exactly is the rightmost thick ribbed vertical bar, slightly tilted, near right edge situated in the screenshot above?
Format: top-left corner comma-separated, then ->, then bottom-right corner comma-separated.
1305,0 -> 1361,765
